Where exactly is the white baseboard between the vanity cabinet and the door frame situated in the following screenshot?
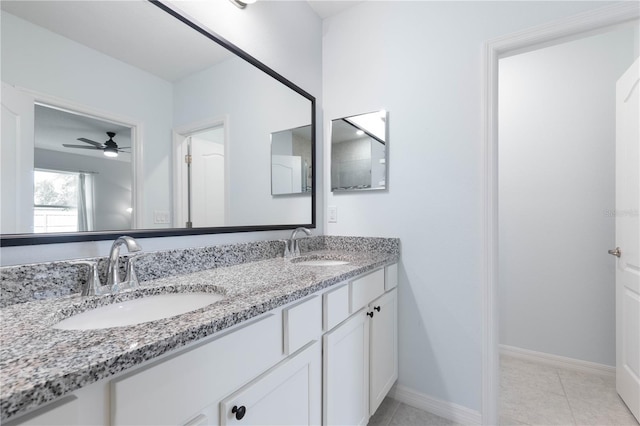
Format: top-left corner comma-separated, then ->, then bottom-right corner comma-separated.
388,384 -> 482,425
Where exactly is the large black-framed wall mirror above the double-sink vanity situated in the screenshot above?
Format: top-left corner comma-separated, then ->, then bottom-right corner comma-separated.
0,0 -> 315,246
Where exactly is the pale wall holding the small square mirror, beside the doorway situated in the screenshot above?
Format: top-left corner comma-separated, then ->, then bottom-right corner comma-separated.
323,1 -> 616,410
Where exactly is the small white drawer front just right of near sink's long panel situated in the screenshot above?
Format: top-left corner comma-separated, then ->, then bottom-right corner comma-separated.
282,295 -> 322,355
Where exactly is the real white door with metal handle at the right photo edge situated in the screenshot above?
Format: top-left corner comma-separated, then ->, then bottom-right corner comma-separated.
610,59 -> 640,421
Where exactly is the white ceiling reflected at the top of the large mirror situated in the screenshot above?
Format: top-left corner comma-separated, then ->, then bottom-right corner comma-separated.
0,0 -> 232,82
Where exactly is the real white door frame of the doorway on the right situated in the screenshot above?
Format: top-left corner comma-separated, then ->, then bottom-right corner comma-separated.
481,2 -> 640,425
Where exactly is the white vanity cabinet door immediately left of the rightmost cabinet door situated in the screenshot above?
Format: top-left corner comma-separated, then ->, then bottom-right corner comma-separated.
323,309 -> 369,425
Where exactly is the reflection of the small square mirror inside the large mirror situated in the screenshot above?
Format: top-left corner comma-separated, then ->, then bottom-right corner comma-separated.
271,125 -> 312,195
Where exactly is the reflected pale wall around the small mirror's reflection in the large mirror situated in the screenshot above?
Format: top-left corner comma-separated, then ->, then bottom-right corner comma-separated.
174,58 -> 311,226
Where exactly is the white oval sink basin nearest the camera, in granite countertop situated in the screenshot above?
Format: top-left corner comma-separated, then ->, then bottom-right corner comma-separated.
53,293 -> 224,330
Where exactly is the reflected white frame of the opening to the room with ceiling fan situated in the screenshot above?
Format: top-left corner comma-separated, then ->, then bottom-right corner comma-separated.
5,86 -> 144,229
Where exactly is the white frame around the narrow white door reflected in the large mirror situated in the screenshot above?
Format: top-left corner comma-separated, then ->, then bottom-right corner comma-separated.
172,115 -> 231,228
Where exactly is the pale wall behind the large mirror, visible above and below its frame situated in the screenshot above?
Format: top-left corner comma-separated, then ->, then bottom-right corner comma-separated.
0,0 -> 323,265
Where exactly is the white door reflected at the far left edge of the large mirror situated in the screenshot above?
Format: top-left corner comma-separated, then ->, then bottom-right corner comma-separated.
0,82 -> 34,234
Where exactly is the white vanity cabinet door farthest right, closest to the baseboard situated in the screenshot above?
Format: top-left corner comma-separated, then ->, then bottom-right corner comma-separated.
369,289 -> 398,415
